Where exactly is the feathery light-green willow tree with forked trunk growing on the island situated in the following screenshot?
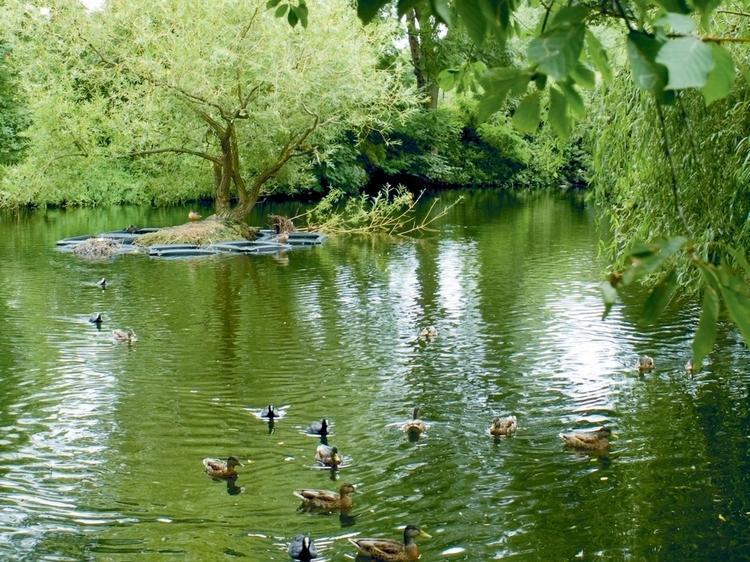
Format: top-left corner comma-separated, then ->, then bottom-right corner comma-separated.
4,0 -> 412,217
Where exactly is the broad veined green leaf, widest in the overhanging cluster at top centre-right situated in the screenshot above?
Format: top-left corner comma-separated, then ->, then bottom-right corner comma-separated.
528,25 -> 586,81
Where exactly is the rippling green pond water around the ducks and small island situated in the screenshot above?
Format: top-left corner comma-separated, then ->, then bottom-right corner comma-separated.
0,191 -> 750,561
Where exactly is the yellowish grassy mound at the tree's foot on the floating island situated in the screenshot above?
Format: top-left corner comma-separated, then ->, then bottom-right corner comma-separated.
135,218 -> 257,246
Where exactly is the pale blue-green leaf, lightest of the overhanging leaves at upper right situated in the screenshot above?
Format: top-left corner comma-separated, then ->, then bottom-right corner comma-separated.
656,37 -> 714,90
